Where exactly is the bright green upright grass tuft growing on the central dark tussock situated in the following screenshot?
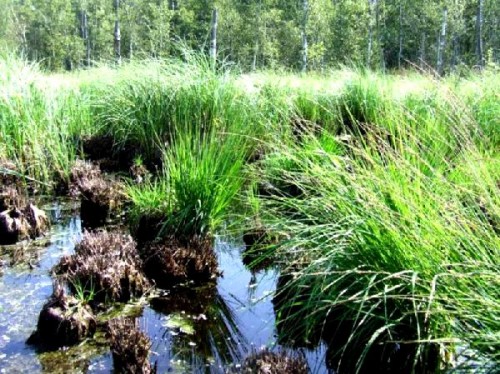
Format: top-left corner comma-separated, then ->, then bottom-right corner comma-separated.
128,124 -> 251,238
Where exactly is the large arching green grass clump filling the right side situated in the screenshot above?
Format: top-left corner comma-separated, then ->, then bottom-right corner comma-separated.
254,76 -> 500,372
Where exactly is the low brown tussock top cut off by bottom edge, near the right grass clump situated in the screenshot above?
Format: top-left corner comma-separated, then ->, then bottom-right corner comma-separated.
240,349 -> 309,374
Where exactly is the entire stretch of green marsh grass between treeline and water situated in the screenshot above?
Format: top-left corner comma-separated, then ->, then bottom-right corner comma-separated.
0,58 -> 500,371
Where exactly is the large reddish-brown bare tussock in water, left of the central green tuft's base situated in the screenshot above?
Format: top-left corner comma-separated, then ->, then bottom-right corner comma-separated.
55,232 -> 151,303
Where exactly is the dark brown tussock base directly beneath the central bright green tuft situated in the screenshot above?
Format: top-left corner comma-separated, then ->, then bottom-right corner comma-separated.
140,237 -> 219,288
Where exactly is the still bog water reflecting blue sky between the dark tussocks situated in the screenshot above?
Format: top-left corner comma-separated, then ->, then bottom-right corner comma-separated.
0,203 -> 327,373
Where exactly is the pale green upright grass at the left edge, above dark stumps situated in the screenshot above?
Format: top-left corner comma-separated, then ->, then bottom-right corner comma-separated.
0,59 -> 91,190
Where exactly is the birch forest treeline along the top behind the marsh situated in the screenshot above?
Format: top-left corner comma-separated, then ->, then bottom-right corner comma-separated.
0,0 -> 500,73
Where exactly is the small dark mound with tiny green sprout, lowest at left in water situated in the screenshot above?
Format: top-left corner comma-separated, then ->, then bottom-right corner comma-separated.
27,285 -> 97,349
